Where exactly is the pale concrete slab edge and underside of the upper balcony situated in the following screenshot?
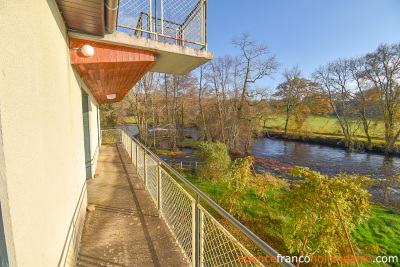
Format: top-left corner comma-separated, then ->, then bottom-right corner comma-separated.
68,31 -> 213,74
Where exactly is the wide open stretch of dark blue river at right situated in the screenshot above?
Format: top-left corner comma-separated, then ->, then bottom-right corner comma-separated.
251,138 -> 400,179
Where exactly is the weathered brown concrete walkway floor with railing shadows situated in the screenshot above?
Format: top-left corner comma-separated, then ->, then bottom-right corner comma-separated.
77,145 -> 187,267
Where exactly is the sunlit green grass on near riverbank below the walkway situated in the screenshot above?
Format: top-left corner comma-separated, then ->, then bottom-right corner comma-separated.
173,170 -> 400,266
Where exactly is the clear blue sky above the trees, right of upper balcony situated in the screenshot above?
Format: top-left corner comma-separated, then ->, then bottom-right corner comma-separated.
208,0 -> 400,87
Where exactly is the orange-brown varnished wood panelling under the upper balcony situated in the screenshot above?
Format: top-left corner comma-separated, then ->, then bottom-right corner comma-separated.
70,38 -> 157,104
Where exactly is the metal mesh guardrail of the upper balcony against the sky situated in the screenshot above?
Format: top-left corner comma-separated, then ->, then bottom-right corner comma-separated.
117,0 -> 207,50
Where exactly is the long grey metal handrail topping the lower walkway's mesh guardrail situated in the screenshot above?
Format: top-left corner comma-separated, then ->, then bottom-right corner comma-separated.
115,128 -> 294,267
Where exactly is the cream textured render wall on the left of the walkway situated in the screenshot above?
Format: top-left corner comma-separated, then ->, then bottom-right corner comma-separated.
0,0 -> 93,266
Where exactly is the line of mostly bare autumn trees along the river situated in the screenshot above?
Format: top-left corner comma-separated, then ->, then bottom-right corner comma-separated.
101,34 -> 400,153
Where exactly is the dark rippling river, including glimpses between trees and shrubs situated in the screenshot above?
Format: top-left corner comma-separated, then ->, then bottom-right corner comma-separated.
125,126 -> 400,203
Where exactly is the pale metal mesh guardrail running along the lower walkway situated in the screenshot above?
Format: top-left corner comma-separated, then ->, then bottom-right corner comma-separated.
102,129 -> 293,267
